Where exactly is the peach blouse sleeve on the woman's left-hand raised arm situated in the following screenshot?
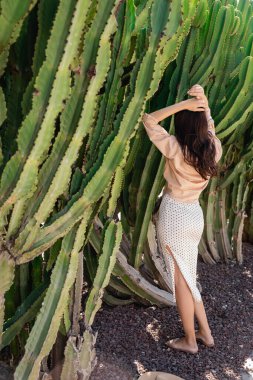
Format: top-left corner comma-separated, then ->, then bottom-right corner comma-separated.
142,112 -> 177,158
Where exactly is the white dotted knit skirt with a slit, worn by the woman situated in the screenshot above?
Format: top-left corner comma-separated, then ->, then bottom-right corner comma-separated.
156,193 -> 204,302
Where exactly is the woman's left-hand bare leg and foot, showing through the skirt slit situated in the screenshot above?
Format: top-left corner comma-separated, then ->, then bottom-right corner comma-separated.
166,245 -> 198,353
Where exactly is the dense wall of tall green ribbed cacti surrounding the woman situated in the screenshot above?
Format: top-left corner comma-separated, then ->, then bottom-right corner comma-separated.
0,0 -> 253,380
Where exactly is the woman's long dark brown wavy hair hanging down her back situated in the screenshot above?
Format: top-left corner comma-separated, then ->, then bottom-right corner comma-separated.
174,110 -> 217,180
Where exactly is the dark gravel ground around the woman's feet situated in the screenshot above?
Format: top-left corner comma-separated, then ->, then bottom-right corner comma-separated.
91,243 -> 253,380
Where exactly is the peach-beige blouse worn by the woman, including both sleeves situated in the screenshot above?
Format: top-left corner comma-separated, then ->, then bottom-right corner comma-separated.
142,113 -> 222,203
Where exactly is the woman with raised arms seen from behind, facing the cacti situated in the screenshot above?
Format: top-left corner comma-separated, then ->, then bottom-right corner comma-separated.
142,84 -> 222,354
